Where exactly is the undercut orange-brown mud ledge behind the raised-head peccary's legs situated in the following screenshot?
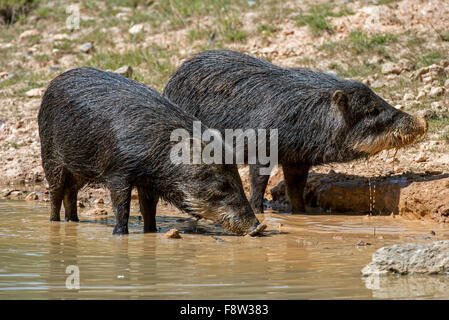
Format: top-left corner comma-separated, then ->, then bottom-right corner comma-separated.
271,173 -> 449,222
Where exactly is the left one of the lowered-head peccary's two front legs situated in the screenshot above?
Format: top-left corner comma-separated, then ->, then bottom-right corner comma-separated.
109,186 -> 132,234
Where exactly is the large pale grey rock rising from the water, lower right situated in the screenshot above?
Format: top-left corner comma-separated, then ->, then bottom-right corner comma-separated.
362,240 -> 449,276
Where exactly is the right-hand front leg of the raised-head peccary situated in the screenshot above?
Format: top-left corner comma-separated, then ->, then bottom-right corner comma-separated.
282,164 -> 310,213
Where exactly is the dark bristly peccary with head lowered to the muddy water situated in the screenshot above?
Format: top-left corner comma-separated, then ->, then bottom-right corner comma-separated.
39,67 -> 259,234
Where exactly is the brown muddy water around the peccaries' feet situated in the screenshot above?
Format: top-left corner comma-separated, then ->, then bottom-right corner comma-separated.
0,201 -> 449,299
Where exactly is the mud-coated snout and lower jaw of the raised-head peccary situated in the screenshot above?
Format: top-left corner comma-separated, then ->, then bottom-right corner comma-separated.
354,116 -> 427,156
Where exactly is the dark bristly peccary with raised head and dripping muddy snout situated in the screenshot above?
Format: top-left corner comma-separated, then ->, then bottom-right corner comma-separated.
164,50 -> 427,213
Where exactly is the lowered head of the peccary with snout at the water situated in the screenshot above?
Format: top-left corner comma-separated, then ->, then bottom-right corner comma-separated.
179,164 -> 259,234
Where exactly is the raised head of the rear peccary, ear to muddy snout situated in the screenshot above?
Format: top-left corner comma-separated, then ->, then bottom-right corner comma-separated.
331,81 -> 427,156
